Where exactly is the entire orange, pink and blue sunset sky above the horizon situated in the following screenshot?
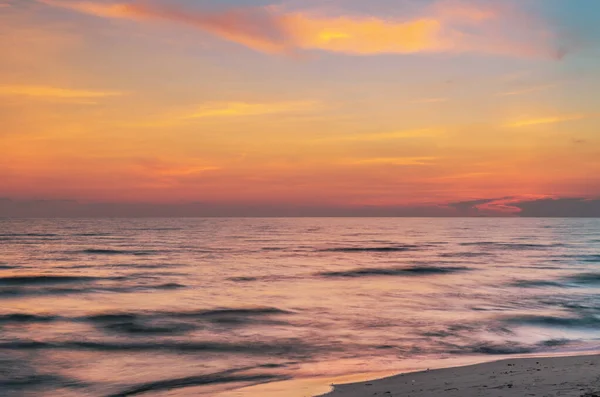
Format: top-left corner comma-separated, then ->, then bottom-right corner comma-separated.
0,0 -> 600,216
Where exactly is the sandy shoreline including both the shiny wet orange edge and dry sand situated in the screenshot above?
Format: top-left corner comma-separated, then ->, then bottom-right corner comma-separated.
217,350 -> 600,397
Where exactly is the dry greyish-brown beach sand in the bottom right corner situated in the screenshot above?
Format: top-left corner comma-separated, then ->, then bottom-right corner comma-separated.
323,355 -> 600,397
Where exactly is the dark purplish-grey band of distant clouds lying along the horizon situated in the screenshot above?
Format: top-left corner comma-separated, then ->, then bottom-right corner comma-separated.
0,197 -> 600,218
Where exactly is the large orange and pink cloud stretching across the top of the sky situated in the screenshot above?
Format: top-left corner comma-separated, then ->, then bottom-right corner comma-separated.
38,0 -> 564,58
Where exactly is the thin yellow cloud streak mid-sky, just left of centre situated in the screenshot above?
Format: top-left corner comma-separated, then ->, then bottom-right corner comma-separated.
183,101 -> 318,120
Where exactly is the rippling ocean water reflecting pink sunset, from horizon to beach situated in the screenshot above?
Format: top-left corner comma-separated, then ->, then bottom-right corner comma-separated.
0,218 -> 600,397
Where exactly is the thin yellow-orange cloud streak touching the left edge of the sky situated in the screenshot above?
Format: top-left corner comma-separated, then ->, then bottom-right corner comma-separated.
0,85 -> 123,100
